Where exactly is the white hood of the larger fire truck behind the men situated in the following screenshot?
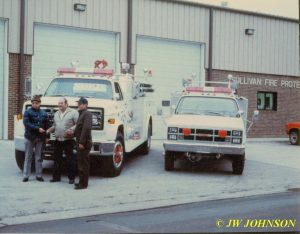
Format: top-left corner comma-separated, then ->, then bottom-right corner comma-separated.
25,97 -> 118,115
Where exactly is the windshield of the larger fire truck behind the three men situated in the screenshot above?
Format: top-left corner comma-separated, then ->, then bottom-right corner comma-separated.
45,78 -> 113,99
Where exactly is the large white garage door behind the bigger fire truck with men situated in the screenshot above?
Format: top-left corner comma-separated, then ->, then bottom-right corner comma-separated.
32,25 -> 119,94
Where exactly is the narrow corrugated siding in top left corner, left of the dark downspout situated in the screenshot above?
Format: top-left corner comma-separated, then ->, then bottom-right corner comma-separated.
0,0 -> 20,53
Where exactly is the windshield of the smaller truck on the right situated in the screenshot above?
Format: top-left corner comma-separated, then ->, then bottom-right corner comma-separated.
175,97 -> 238,117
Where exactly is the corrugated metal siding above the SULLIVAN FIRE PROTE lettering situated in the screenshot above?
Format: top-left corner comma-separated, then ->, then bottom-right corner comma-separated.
213,11 -> 299,76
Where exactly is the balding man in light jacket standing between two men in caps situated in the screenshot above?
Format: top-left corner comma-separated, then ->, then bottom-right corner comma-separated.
47,98 -> 79,184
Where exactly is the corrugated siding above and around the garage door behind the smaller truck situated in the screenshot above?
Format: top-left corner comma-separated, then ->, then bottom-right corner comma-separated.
132,0 -> 209,64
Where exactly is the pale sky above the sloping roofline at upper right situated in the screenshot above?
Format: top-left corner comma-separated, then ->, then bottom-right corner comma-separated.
187,0 -> 299,19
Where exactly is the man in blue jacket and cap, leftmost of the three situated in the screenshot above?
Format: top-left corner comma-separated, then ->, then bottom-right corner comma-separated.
23,95 -> 49,182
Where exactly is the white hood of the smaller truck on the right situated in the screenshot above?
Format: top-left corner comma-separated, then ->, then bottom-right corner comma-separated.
167,115 -> 244,131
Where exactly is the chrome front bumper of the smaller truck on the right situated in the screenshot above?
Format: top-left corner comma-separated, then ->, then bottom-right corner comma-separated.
163,141 -> 245,155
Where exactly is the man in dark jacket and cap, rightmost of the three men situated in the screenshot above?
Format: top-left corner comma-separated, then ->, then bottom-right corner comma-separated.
75,98 -> 92,189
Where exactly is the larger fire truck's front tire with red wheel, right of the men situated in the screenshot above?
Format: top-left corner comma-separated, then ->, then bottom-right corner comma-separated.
103,133 -> 125,177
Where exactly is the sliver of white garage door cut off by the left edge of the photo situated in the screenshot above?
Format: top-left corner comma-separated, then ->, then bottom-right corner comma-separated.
0,20 -> 7,139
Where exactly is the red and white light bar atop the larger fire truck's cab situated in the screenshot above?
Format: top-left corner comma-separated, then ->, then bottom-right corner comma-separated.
57,67 -> 113,76
